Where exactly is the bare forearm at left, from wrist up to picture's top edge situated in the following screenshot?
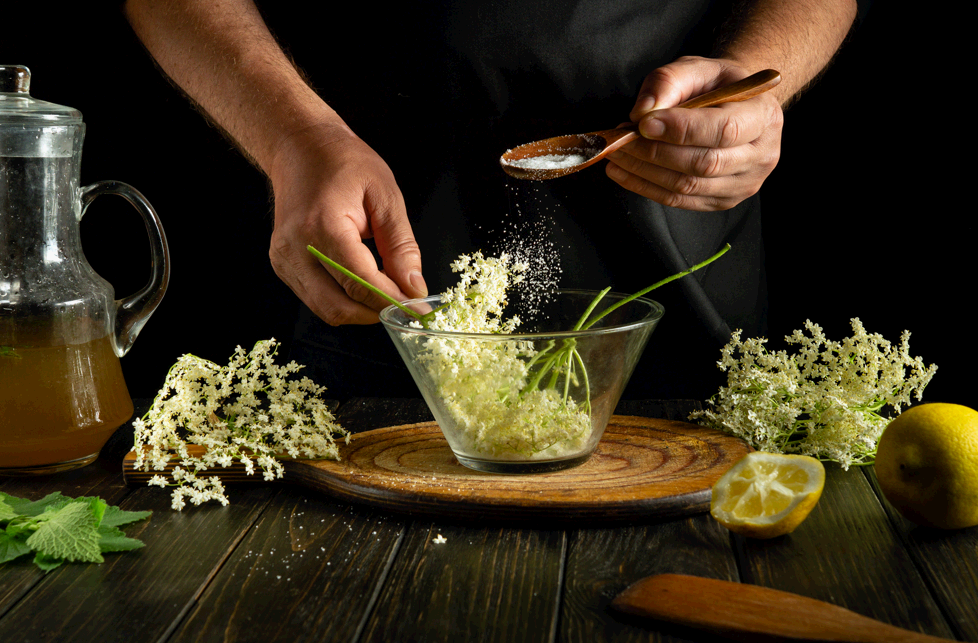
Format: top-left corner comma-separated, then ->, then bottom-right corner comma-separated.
126,0 -> 344,173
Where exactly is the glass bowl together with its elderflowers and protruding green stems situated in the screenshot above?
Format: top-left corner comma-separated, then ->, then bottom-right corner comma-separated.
307,244 -> 730,473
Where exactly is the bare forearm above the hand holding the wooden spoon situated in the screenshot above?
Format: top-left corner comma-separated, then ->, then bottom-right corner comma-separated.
717,0 -> 856,105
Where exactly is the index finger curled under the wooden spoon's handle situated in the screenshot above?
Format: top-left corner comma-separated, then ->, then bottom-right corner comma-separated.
638,95 -> 783,148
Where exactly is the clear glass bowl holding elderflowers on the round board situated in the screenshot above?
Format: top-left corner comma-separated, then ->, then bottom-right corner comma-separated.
380,290 -> 664,473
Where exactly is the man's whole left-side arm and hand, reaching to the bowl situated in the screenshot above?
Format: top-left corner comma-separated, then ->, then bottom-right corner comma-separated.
126,0 -> 427,325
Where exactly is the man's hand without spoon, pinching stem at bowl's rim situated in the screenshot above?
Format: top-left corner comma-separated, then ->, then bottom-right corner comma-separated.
269,124 -> 428,326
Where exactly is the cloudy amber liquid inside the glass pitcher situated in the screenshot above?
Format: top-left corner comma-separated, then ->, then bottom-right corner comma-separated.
0,336 -> 133,473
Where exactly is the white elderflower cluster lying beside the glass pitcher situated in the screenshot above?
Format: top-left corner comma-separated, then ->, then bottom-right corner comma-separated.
133,338 -> 350,511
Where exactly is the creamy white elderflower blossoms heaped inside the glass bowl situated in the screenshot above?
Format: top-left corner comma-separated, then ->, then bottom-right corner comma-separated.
406,253 -> 591,459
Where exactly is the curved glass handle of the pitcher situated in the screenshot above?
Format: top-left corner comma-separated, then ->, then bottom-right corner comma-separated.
78,181 -> 170,357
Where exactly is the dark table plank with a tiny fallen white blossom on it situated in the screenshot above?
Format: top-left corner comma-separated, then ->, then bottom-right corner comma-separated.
360,523 -> 565,643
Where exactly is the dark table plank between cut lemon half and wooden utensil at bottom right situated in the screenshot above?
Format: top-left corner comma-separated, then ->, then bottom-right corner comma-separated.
732,465 -> 953,638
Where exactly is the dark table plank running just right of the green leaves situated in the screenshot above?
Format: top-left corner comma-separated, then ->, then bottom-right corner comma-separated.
0,486 -> 271,643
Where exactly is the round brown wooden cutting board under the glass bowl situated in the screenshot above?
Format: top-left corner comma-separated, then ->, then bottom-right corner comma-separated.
123,415 -> 751,524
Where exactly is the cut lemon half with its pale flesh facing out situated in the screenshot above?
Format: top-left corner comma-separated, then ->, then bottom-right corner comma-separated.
710,451 -> 825,538
